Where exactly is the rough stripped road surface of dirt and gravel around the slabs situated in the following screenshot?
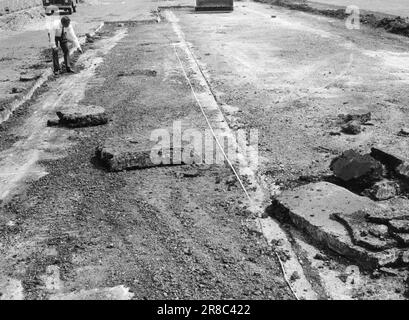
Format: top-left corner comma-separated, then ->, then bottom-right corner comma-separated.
0,2 -> 409,299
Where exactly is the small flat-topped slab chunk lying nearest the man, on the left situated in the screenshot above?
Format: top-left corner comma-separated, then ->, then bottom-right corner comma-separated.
57,105 -> 108,128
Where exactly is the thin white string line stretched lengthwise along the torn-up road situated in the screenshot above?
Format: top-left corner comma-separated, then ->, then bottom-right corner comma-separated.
173,44 -> 299,300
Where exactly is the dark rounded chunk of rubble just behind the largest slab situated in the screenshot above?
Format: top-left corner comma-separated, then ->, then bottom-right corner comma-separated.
330,150 -> 383,181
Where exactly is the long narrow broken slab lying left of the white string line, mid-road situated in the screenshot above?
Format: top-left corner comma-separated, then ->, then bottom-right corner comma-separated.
96,137 -> 202,171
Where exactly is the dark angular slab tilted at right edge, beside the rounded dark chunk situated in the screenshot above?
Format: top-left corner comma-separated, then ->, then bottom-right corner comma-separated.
371,144 -> 409,178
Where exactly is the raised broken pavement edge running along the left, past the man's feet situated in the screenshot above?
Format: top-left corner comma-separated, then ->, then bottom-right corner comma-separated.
0,21 -> 105,124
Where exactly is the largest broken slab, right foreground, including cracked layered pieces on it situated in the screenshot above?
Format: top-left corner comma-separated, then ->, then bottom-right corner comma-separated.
270,182 -> 409,269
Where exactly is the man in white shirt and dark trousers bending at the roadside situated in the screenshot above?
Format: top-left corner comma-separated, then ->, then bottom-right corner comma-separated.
48,16 -> 82,73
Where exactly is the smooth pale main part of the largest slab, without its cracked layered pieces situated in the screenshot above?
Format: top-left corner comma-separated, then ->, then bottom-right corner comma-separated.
270,182 -> 399,269
